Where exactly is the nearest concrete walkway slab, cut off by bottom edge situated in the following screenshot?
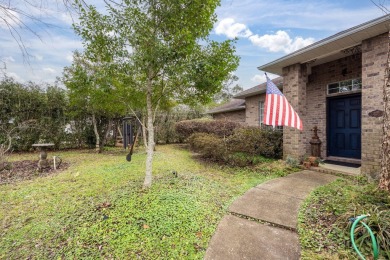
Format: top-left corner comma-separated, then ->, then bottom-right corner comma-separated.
204,215 -> 300,260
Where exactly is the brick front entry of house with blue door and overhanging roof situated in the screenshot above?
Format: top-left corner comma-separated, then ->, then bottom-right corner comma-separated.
258,16 -> 390,179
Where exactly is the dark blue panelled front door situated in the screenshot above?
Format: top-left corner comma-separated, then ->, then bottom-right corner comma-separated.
328,95 -> 362,159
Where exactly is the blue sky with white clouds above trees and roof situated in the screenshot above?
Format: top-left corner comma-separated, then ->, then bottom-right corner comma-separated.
0,0 -> 390,89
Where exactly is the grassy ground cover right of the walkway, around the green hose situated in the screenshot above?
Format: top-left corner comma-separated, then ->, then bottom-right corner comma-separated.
298,177 -> 390,259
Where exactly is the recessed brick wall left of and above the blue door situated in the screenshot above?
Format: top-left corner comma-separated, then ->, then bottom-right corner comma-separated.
305,54 -> 362,157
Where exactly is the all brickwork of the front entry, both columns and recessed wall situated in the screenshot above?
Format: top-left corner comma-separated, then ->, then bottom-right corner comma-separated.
283,34 -> 388,179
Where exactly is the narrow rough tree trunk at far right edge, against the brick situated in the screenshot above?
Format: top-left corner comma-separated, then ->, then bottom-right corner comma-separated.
379,31 -> 390,191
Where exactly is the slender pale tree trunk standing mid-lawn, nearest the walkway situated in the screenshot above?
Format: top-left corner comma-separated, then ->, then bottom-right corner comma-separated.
144,78 -> 154,189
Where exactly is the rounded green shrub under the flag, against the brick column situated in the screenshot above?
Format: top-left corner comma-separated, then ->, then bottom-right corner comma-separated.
228,127 -> 283,158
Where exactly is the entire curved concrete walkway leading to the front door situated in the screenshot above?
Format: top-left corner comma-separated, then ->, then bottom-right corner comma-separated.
205,170 -> 337,260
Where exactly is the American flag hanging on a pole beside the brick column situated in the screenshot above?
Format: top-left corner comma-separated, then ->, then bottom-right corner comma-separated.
263,74 -> 303,130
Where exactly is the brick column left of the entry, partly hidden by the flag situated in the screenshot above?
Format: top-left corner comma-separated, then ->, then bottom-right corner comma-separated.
283,64 -> 309,159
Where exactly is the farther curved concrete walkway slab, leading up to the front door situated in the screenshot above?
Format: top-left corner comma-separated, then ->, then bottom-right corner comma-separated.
229,171 -> 337,230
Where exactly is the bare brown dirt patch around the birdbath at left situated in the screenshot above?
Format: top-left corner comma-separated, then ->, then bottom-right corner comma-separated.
0,160 -> 69,185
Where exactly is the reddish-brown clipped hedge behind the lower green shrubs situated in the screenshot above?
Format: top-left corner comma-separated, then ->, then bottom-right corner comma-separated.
175,119 -> 241,140
